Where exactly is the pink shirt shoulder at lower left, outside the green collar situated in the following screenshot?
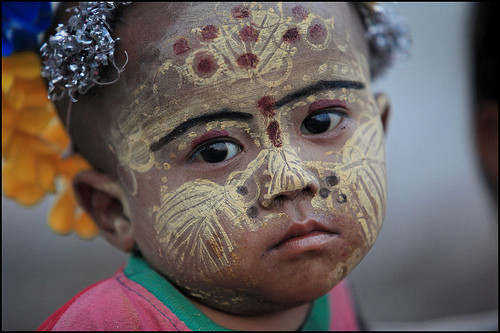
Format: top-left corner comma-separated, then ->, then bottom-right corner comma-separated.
38,269 -> 189,331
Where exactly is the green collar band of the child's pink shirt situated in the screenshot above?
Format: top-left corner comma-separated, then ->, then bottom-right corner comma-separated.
124,255 -> 330,331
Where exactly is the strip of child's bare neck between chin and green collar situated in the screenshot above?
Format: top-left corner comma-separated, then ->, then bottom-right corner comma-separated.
189,299 -> 311,331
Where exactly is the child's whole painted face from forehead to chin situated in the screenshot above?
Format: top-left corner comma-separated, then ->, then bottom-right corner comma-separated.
105,3 -> 386,314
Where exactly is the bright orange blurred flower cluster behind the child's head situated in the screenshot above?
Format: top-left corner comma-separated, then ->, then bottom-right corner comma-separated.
2,52 -> 98,238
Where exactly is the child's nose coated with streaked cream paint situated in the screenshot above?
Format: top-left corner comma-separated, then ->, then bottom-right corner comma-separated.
260,150 -> 319,208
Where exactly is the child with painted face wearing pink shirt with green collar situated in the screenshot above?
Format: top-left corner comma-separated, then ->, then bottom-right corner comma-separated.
3,3 -> 410,330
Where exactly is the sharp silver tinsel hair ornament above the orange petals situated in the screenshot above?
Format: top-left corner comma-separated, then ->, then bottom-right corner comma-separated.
40,2 -> 130,102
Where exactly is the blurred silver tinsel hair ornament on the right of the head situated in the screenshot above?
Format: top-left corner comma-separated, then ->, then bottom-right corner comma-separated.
354,2 -> 412,79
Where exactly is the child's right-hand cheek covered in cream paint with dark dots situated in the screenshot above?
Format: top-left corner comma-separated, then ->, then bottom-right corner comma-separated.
311,118 -> 387,246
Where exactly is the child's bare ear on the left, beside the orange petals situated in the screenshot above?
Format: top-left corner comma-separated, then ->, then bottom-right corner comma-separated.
73,170 -> 135,252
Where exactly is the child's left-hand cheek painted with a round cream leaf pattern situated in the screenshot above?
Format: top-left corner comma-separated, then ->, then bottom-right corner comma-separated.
154,179 -> 258,279
